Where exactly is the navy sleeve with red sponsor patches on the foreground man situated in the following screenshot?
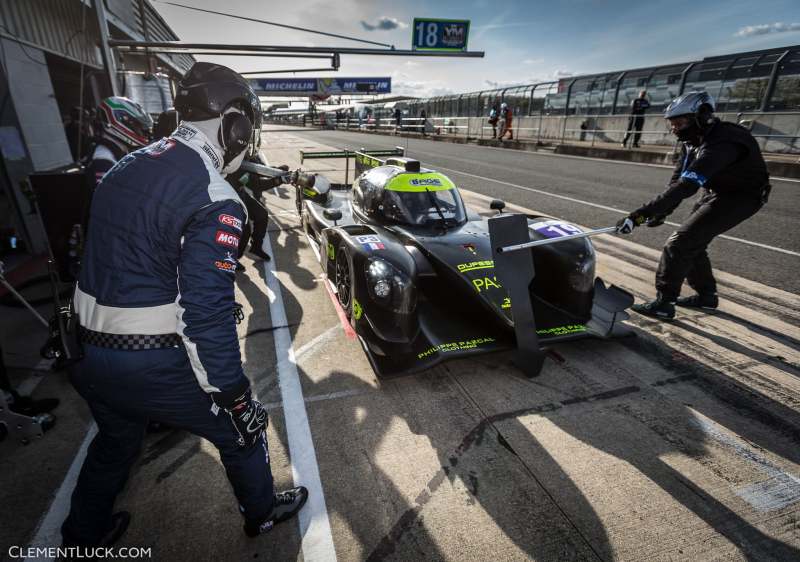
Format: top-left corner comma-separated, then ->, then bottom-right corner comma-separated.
178,200 -> 250,407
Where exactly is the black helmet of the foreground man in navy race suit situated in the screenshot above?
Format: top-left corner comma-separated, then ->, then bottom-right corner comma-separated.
175,62 -> 261,123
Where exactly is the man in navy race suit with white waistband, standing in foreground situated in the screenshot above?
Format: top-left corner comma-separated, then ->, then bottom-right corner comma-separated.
62,62 -> 308,547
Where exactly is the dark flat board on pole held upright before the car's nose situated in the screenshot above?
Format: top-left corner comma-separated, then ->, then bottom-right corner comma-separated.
489,214 -> 545,378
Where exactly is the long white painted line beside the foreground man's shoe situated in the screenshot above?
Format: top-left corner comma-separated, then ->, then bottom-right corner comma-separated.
264,236 -> 336,562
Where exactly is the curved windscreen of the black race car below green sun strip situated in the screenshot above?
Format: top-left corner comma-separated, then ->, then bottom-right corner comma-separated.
383,189 -> 466,226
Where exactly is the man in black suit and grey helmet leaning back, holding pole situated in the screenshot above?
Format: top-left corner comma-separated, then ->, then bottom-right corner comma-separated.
617,92 -> 770,319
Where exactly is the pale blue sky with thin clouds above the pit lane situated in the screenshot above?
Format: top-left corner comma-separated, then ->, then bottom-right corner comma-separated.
150,0 -> 800,97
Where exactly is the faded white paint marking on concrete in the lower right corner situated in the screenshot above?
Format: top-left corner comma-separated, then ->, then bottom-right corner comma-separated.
691,410 -> 800,512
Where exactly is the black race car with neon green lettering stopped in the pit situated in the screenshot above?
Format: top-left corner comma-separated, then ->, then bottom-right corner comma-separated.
292,149 -> 633,376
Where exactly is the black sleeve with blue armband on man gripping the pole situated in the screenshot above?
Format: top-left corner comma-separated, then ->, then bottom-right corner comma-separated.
634,143 -> 741,217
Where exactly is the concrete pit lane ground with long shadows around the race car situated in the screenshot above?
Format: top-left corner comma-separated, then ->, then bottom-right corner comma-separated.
0,131 -> 800,561
